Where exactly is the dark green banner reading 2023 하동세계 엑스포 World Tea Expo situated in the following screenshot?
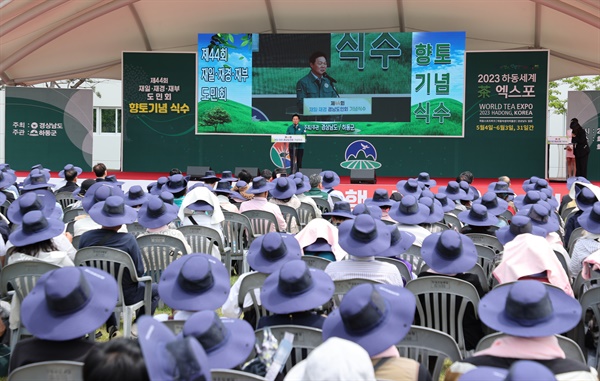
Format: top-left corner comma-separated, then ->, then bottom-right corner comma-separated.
464,50 -> 549,177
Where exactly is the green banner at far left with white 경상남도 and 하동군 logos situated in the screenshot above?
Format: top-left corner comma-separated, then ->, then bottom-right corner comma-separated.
5,87 -> 93,171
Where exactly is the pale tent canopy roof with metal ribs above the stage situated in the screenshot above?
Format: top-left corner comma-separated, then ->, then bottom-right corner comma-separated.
0,0 -> 600,85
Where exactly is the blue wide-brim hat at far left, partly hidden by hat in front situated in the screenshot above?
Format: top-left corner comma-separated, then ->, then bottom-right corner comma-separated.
7,189 -> 62,225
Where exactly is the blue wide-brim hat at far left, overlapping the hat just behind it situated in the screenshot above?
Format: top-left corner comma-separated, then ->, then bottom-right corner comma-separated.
8,210 -> 65,247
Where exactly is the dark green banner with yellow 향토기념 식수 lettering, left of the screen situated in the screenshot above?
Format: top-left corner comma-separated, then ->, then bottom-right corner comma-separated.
122,52 -> 197,171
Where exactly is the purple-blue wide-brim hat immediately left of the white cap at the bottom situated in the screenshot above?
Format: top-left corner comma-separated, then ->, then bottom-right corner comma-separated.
182,311 -> 256,369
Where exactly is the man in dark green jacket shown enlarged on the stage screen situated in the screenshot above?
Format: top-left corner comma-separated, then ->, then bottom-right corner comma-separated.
296,52 -> 339,114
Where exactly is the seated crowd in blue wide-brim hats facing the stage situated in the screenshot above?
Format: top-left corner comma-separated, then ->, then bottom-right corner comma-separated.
0,164 -> 600,381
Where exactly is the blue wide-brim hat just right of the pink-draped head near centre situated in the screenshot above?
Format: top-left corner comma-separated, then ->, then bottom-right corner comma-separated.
338,214 -> 391,257
